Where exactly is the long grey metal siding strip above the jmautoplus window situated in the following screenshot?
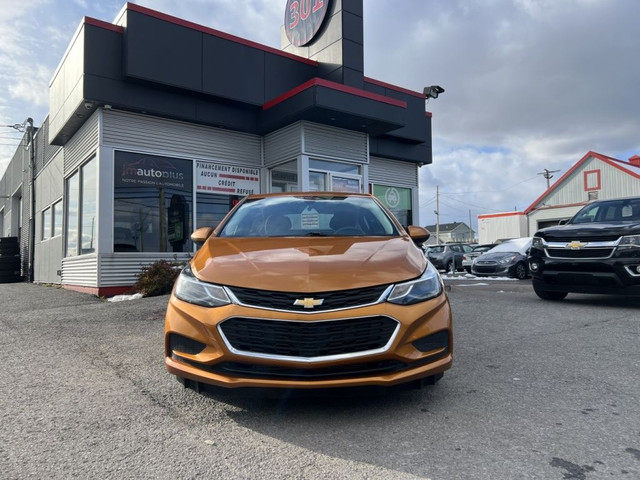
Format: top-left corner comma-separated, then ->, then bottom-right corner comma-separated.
101,110 -> 262,167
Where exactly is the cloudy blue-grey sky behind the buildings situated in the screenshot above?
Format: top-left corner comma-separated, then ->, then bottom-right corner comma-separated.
0,0 -> 640,228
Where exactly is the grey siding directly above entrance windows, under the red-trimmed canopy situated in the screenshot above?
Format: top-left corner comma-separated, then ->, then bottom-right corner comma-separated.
303,122 -> 369,163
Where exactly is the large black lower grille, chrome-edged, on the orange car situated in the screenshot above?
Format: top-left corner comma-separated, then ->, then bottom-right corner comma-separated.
218,316 -> 399,359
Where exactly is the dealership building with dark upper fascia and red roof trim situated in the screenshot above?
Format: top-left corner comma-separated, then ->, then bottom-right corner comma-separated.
0,0 -> 432,295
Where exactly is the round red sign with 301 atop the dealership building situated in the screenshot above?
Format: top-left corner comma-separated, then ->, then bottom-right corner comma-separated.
284,0 -> 330,47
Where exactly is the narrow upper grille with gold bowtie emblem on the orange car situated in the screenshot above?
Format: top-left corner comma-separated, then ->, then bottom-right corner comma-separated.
228,285 -> 388,313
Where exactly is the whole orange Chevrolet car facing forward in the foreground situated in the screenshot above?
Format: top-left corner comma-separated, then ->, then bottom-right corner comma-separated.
165,192 -> 453,390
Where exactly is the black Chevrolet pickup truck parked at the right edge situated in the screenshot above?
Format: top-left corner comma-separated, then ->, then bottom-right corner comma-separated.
528,197 -> 640,300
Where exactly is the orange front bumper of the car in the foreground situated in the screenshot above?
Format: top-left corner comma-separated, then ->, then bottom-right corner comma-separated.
165,294 -> 453,388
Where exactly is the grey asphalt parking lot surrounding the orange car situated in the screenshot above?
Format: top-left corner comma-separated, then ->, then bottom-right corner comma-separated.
0,282 -> 640,480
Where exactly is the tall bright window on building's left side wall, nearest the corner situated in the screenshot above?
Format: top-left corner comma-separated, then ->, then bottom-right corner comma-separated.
65,158 -> 98,257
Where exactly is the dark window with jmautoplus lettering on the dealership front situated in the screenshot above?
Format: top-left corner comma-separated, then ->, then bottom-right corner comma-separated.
113,151 -> 193,252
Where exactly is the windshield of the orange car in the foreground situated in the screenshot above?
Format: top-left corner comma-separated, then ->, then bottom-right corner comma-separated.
220,195 -> 399,237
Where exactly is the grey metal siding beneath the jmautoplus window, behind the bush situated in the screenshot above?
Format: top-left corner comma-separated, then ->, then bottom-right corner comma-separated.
100,253 -> 191,287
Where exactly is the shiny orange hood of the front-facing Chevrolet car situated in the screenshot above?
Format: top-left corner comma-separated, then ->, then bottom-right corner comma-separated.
191,237 -> 427,292
